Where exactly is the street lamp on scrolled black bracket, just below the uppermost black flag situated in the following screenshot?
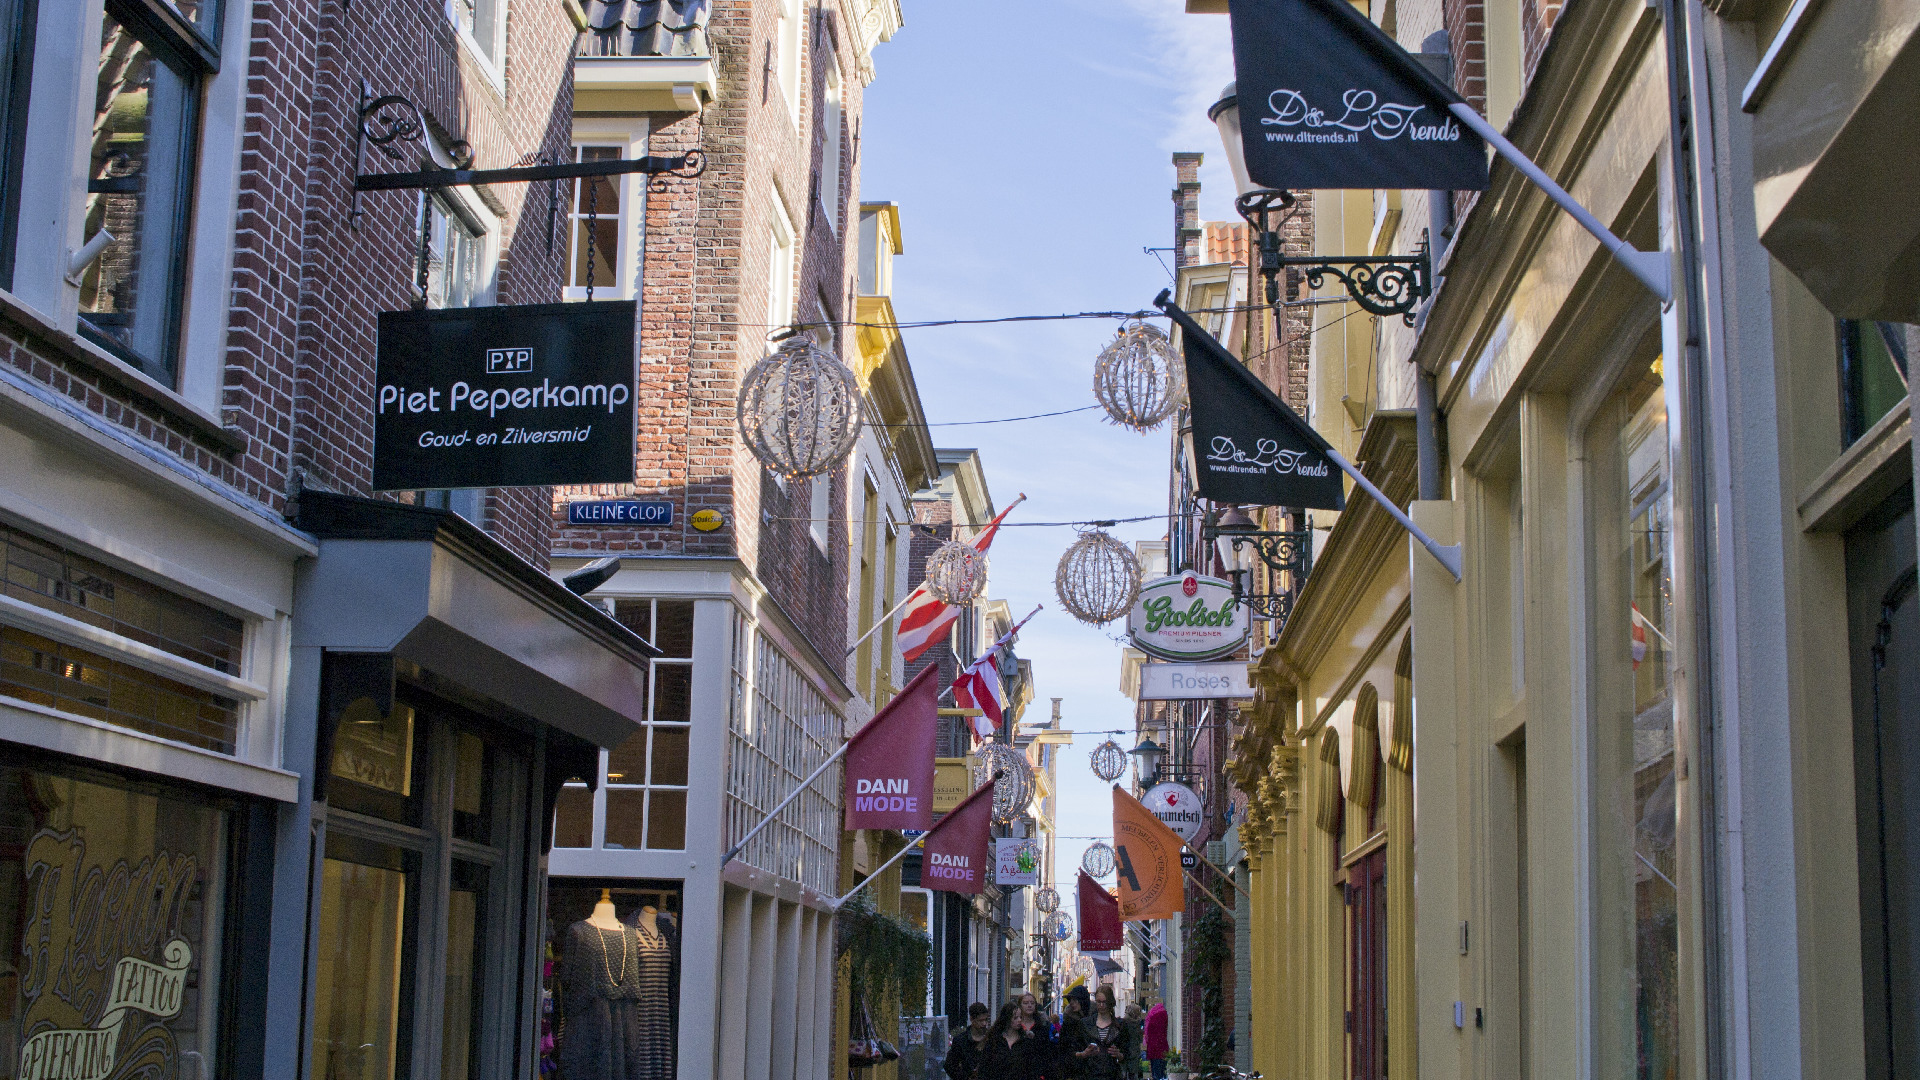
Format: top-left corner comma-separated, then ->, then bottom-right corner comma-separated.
1206,83 -> 1432,327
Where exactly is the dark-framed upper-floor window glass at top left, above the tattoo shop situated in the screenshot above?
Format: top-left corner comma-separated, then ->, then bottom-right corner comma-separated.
81,0 -> 221,386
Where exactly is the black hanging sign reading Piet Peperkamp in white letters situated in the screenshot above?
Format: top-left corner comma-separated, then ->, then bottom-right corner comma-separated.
372,300 -> 636,492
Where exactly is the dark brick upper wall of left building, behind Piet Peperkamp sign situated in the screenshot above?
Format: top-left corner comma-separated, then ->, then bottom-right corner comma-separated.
0,0 -> 574,565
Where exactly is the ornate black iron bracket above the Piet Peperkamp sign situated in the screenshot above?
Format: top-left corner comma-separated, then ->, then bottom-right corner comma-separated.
349,83 -> 707,230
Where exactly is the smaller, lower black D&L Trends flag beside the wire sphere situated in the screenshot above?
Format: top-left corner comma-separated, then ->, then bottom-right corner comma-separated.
1154,292 -> 1346,509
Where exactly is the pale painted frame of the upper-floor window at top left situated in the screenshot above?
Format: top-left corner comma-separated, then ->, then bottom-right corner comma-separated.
12,0 -> 255,417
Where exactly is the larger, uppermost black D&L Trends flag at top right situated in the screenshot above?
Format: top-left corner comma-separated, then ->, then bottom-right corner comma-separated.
1227,0 -> 1486,190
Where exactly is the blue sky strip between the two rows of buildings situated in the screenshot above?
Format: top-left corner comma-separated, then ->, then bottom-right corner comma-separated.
860,0 -> 1233,891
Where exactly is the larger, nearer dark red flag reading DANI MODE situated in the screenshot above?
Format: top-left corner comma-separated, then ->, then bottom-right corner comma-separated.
847,667 -> 941,830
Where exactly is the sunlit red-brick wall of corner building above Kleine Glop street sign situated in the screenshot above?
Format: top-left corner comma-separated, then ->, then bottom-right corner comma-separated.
551,0 -> 862,655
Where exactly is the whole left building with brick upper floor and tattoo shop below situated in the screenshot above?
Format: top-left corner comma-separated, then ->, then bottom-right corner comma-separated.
0,0 -> 659,1078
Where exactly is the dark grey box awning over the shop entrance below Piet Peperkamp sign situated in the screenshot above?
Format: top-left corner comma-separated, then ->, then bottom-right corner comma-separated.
294,492 -> 659,748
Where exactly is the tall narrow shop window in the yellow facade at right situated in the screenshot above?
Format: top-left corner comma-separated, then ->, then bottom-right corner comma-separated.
1588,359 -> 1686,1080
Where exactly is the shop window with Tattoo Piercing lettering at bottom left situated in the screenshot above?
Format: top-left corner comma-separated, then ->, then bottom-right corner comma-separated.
0,755 -> 236,1076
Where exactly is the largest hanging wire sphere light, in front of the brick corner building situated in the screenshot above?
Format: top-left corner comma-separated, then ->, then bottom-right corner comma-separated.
737,334 -> 860,480
